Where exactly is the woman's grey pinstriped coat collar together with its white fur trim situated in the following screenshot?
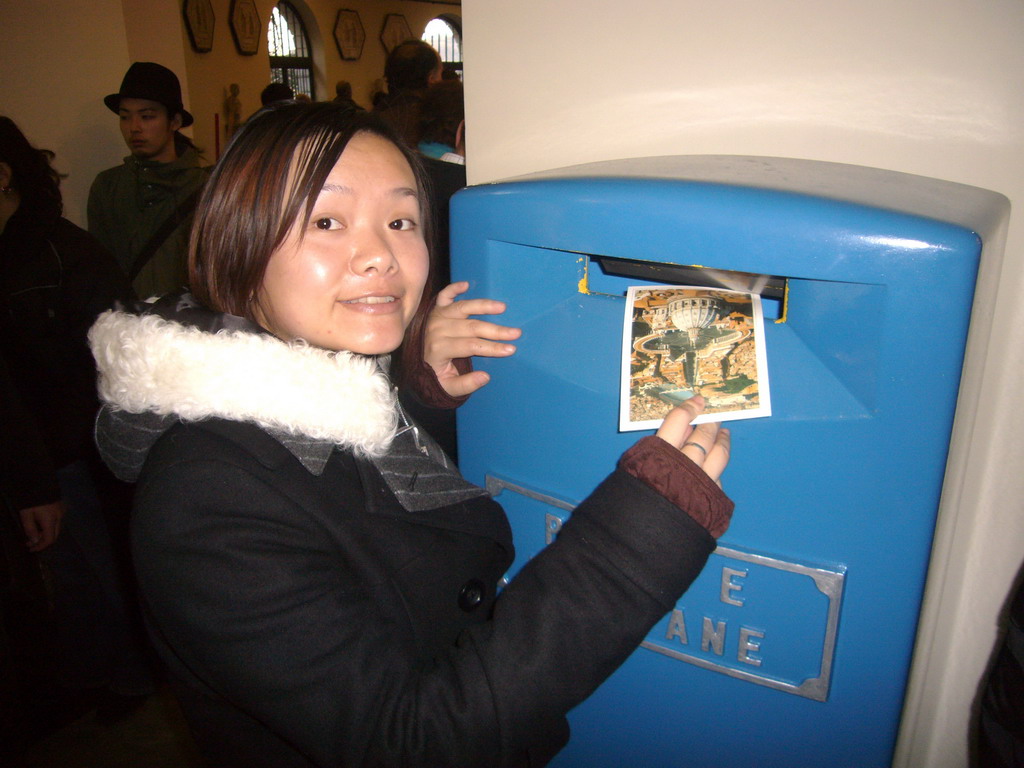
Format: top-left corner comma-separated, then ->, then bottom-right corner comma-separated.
89,294 -> 486,524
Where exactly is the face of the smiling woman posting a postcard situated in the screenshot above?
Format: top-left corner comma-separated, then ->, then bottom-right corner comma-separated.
255,133 -> 428,354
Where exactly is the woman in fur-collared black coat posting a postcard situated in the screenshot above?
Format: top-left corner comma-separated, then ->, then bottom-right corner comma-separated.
90,102 -> 732,768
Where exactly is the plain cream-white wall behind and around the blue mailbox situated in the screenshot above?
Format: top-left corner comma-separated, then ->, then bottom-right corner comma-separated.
463,0 -> 1024,768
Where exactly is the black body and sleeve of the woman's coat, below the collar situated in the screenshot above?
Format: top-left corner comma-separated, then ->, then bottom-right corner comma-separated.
133,420 -> 715,768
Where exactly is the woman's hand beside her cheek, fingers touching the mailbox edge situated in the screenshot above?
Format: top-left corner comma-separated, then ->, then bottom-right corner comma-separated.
423,282 -> 522,397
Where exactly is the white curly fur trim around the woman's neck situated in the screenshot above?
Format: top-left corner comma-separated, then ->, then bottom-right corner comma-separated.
89,311 -> 398,457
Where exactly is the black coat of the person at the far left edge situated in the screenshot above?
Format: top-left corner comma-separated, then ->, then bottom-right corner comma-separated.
0,209 -> 128,508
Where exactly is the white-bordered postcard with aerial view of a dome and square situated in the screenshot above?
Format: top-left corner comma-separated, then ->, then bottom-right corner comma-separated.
618,286 -> 771,431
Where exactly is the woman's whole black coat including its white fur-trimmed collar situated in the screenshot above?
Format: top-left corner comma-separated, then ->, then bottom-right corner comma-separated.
90,296 -> 727,768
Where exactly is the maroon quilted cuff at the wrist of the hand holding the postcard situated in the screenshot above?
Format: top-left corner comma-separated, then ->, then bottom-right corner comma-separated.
618,435 -> 735,539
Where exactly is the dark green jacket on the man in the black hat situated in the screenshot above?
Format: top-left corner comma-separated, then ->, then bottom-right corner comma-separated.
88,140 -> 210,299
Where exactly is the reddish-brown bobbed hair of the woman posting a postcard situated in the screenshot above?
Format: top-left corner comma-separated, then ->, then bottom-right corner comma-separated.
188,101 -> 433,378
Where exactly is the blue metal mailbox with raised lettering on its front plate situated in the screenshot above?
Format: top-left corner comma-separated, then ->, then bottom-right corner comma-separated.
452,157 -> 1009,768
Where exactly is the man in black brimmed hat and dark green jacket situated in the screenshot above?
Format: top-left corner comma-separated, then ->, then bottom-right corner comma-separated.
88,61 -> 210,298
